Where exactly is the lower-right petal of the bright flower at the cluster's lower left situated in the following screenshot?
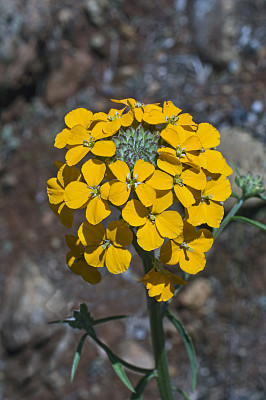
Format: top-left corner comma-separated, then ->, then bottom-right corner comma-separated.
105,246 -> 131,274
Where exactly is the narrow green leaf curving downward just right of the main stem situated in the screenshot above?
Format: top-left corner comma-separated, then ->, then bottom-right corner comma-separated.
166,310 -> 197,391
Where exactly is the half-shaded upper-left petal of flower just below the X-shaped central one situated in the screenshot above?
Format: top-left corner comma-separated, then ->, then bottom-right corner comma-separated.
122,200 -> 149,226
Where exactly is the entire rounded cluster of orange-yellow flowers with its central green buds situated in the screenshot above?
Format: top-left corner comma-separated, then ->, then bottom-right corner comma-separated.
47,98 -> 232,301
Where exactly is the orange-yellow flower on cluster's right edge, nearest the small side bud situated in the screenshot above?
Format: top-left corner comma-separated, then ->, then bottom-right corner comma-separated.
186,176 -> 231,228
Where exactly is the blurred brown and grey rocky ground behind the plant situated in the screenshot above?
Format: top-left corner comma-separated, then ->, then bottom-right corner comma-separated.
0,0 -> 266,400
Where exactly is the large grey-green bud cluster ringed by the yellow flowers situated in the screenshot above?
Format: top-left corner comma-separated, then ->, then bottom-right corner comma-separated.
113,124 -> 160,170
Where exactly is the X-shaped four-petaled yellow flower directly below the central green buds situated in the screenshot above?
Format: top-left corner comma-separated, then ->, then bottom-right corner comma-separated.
108,160 -> 156,206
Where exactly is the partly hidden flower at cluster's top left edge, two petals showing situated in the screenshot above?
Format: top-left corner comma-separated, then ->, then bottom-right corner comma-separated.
54,108 -> 93,149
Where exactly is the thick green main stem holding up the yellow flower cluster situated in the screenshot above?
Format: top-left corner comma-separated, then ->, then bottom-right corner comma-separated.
133,232 -> 173,400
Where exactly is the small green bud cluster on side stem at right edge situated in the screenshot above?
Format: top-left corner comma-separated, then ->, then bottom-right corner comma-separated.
235,172 -> 265,199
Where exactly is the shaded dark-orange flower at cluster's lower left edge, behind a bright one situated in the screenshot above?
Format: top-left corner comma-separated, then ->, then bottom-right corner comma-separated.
66,235 -> 101,285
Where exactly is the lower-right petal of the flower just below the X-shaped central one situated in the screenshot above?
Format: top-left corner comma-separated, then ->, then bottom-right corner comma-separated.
155,210 -> 183,239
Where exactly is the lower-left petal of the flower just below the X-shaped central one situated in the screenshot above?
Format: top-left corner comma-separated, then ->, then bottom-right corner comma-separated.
137,220 -> 164,251
